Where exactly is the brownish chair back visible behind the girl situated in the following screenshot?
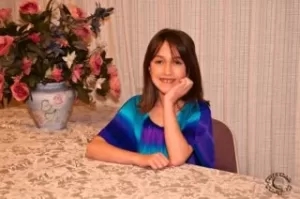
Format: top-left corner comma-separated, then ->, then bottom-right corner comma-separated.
212,119 -> 238,173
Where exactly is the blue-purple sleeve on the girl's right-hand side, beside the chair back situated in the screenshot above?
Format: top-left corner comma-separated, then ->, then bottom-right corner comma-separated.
182,102 -> 215,168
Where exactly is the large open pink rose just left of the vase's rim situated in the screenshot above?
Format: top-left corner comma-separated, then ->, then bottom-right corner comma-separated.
10,77 -> 29,102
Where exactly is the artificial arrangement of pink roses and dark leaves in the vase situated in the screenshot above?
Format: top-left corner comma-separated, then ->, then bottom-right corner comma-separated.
0,0 -> 120,107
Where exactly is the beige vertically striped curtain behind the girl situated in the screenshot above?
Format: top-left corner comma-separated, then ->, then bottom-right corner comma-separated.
5,0 -> 300,184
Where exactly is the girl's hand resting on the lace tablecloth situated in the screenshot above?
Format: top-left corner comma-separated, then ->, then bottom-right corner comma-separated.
137,153 -> 169,169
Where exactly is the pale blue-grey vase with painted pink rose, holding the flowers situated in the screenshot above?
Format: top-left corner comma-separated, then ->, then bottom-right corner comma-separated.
26,82 -> 75,130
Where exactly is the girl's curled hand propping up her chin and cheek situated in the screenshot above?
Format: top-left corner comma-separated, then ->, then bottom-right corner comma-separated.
164,77 -> 193,104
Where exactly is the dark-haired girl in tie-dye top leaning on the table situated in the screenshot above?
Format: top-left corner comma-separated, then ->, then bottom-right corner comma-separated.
86,29 -> 215,169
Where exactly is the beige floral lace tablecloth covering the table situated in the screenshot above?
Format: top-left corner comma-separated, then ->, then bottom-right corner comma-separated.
0,106 -> 300,199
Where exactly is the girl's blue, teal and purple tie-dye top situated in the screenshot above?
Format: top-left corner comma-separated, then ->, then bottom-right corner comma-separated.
99,95 -> 215,168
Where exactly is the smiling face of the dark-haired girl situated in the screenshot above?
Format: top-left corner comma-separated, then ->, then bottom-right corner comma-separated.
149,42 -> 186,94
